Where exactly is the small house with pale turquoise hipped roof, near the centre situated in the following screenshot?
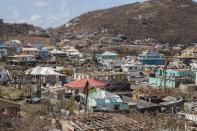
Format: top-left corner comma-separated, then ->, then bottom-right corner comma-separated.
99,51 -> 118,60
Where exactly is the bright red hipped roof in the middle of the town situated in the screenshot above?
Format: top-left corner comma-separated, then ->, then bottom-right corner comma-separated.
64,79 -> 105,88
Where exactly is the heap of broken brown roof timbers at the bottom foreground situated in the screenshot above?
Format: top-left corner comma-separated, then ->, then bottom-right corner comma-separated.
70,113 -> 147,131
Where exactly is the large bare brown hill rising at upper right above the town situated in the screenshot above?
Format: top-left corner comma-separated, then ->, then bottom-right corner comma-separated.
55,0 -> 197,43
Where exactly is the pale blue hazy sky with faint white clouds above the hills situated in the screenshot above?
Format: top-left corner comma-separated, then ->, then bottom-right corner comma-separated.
0,0 -> 146,27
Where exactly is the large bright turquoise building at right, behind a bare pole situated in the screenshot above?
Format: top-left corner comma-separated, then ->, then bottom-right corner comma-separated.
149,69 -> 196,88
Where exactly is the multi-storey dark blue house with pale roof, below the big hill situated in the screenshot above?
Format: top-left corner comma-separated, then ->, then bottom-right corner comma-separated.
138,51 -> 165,65
